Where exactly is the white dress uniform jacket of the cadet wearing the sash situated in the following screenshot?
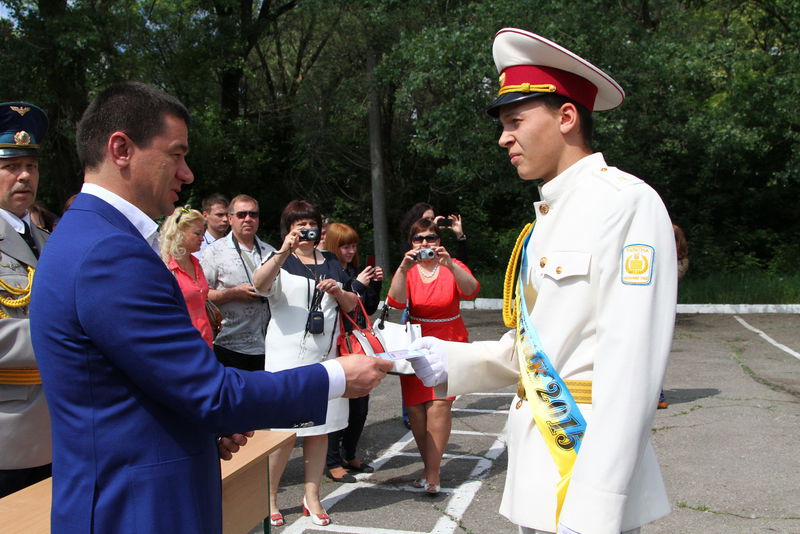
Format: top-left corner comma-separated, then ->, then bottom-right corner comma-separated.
440,153 -> 677,534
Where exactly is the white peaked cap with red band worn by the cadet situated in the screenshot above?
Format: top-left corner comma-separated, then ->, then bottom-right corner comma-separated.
486,28 -> 625,117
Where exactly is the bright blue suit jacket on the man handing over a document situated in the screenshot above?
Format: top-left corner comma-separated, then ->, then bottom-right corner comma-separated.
31,194 -> 328,534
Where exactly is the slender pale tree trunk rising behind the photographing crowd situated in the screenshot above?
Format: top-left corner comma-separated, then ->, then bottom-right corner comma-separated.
367,51 -> 390,275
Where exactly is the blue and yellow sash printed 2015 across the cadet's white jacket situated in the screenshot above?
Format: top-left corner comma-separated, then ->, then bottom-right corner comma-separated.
514,222 -> 586,524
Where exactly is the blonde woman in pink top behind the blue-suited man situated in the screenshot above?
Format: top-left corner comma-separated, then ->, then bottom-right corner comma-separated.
159,208 -> 214,347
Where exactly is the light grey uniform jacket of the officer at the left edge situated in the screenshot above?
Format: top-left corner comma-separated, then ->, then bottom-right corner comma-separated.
0,217 -> 52,470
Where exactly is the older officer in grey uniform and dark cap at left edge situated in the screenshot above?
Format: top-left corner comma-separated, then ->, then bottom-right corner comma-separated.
0,102 -> 52,497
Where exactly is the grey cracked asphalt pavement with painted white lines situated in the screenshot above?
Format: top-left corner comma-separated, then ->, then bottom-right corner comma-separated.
247,311 -> 800,534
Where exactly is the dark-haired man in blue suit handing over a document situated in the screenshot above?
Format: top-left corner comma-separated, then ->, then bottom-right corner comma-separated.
31,82 -> 391,533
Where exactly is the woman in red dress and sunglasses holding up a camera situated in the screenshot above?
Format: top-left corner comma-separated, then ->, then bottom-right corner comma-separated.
388,219 -> 480,495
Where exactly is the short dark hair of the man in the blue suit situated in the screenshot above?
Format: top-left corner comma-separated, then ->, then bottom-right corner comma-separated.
75,82 -> 190,169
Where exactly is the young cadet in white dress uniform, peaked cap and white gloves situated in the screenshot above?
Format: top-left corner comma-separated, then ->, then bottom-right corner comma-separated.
411,28 -> 677,534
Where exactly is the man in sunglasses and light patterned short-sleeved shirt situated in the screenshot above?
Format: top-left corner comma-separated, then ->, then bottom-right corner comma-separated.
201,195 -> 275,371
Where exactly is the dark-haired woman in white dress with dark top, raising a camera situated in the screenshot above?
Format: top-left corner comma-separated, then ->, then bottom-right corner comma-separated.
253,200 -> 357,526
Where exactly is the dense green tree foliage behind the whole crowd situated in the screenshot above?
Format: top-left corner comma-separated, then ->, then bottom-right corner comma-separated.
0,0 -> 800,274
